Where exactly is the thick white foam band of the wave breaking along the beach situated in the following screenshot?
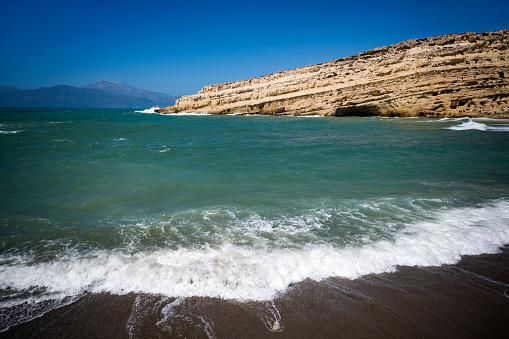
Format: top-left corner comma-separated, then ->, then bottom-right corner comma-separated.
0,200 -> 509,307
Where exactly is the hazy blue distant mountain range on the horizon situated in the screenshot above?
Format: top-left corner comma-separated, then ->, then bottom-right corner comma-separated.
0,80 -> 179,108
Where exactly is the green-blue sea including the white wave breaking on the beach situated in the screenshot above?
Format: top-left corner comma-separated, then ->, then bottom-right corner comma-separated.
0,108 -> 509,331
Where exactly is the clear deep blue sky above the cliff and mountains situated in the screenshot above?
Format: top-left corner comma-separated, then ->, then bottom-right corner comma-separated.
0,0 -> 509,95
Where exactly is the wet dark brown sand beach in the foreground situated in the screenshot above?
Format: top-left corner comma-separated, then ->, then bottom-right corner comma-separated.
0,246 -> 509,338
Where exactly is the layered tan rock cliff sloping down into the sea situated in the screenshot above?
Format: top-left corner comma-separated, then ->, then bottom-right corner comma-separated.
158,30 -> 509,118
